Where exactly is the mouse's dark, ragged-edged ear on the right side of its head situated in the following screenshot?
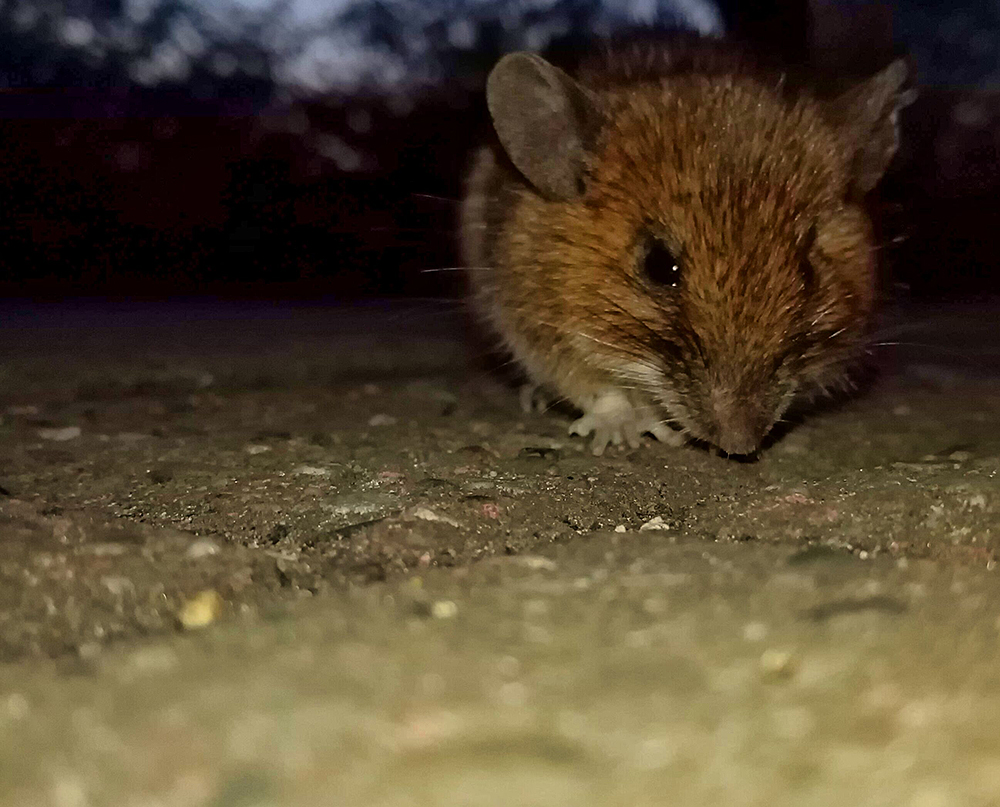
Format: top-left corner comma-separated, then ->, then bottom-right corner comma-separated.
825,59 -> 916,194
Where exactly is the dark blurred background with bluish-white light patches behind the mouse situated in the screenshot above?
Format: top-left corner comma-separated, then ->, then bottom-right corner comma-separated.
0,0 -> 1000,299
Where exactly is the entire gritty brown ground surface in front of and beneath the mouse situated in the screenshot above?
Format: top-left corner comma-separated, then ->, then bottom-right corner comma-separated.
0,303 -> 1000,807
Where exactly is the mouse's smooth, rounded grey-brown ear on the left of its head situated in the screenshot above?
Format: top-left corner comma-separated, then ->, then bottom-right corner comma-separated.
486,53 -> 598,199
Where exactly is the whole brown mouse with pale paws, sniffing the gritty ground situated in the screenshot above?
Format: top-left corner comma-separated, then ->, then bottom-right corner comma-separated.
462,38 -> 908,454
